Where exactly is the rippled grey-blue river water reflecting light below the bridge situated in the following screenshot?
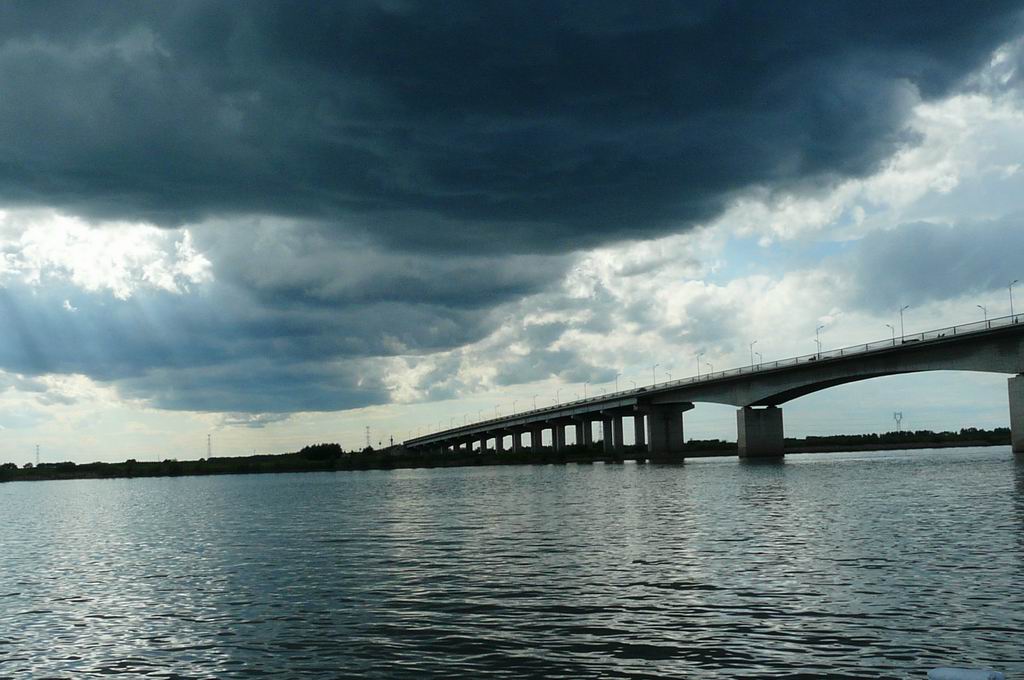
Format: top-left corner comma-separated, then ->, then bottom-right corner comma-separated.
0,449 -> 1024,678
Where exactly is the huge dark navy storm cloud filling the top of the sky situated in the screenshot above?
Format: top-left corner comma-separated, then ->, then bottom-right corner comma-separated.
0,0 -> 1019,251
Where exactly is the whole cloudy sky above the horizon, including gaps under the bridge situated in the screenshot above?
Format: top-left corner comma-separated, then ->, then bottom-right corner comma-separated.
0,0 -> 1024,464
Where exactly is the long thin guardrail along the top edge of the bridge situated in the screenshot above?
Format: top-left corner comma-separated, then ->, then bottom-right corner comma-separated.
407,314 -> 1024,442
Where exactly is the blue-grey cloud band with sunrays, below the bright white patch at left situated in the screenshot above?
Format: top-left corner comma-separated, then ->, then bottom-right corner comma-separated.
0,274 -> 492,414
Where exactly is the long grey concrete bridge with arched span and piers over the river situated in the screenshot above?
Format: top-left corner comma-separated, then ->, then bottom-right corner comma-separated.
403,314 -> 1024,457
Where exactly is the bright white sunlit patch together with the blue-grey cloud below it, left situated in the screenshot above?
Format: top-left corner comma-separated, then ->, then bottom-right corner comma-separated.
0,212 -> 570,413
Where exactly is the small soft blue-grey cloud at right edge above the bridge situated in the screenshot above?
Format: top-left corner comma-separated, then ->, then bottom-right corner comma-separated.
849,213 -> 1024,316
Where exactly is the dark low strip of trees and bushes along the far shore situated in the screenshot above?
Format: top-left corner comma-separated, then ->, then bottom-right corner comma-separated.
0,427 -> 1010,482
